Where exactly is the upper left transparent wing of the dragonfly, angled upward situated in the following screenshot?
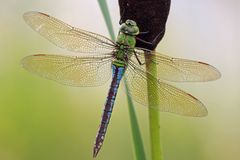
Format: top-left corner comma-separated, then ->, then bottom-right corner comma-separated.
23,12 -> 115,54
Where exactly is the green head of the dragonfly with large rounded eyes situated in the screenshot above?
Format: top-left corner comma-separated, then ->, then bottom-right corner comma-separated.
120,19 -> 139,36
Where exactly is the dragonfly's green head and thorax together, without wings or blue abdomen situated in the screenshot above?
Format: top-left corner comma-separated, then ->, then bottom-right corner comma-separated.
113,20 -> 139,66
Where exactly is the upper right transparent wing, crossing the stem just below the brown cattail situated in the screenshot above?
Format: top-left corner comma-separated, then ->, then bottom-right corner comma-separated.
134,48 -> 221,82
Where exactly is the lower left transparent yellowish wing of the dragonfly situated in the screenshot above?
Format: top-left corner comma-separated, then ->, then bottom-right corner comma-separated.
21,54 -> 112,86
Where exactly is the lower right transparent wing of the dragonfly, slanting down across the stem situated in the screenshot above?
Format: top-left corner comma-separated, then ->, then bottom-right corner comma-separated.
125,61 -> 207,117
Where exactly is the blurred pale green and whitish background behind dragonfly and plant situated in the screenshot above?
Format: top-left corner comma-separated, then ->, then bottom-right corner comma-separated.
0,0 -> 240,160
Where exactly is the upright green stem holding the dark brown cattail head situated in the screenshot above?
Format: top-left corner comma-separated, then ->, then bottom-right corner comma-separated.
145,54 -> 162,160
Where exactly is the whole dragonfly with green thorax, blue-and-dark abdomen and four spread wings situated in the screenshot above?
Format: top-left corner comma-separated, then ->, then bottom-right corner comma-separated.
21,11 -> 221,157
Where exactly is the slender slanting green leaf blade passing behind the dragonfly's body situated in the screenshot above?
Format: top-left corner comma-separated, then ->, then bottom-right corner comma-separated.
98,0 -> 146,160
